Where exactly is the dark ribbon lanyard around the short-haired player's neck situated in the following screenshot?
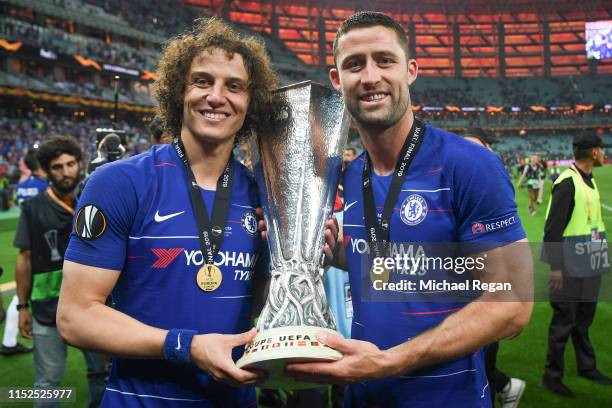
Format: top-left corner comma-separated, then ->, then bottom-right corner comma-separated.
363,118 -> 424,257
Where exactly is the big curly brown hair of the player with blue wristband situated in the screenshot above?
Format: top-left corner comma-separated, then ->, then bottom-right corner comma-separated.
155,17 -> 278,141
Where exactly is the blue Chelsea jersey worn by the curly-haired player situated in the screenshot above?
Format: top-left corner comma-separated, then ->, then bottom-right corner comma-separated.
65,145 -> 267,407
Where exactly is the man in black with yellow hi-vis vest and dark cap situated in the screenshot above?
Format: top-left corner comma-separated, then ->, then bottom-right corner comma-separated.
542,133 -> 612,397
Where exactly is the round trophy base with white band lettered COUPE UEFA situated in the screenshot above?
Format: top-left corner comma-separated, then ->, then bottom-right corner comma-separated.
236,326 -> 342,390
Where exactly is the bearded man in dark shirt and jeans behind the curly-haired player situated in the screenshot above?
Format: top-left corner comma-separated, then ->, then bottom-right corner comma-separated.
14,136 -> 108,407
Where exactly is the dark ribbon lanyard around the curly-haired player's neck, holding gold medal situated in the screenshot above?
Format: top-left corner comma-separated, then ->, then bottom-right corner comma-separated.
172,137 -> 234,265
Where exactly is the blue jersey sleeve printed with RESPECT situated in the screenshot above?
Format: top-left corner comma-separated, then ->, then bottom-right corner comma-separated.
453,148 -> 525,245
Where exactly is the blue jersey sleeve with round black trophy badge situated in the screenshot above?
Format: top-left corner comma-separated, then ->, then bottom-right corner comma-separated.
65,162 -> 138,271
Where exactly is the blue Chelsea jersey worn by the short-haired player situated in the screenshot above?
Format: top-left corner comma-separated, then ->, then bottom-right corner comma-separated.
344,126 -> 525,408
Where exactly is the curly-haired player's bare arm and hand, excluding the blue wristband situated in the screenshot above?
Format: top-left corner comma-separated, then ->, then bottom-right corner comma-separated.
57,261 -> 262,385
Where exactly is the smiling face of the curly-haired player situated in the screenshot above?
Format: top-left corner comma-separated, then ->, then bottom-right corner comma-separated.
181,48 -> 249,143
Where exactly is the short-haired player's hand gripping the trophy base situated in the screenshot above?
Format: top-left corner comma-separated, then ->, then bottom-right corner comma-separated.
285,332 -> 391,385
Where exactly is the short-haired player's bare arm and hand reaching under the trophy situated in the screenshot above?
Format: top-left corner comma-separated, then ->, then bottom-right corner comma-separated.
287,240 -> 533,384
